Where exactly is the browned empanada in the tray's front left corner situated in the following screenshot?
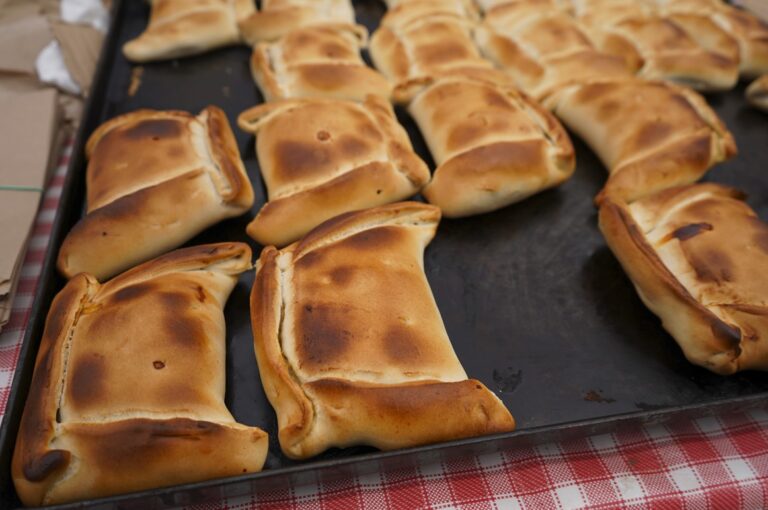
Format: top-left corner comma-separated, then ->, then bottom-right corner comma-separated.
12,243 -> 267,506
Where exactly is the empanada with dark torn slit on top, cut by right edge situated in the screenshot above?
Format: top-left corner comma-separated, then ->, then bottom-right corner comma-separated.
600,183 -> 768,374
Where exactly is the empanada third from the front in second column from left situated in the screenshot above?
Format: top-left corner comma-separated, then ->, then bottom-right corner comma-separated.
251,24 -> 391,101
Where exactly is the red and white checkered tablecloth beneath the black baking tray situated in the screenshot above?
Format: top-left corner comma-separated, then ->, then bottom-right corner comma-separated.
0,146 -> 768,510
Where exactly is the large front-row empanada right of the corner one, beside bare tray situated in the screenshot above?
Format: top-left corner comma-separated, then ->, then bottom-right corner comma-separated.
251,203 -> 514,459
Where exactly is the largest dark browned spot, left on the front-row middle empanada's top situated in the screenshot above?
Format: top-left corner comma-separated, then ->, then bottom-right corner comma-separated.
296,305 -> 352,366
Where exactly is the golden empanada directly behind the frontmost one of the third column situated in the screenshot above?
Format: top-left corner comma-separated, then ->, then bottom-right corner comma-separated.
370,0 -> 492,84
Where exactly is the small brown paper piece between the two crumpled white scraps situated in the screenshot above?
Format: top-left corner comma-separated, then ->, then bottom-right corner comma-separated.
51,22 -> 104,95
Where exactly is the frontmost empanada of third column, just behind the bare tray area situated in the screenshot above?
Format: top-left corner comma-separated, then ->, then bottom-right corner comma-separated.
400,71 -> 575,217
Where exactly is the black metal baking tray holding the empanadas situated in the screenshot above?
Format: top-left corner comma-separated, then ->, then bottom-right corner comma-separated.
0,0 -> 768,509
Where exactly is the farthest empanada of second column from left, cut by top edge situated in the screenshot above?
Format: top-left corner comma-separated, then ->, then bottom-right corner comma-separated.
240,0 -> 355,46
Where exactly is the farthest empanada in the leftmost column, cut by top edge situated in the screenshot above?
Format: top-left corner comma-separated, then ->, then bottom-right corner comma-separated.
123,0 -> 256,62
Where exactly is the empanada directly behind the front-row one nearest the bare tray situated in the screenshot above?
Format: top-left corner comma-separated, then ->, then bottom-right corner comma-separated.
238,96 -> 429,246
